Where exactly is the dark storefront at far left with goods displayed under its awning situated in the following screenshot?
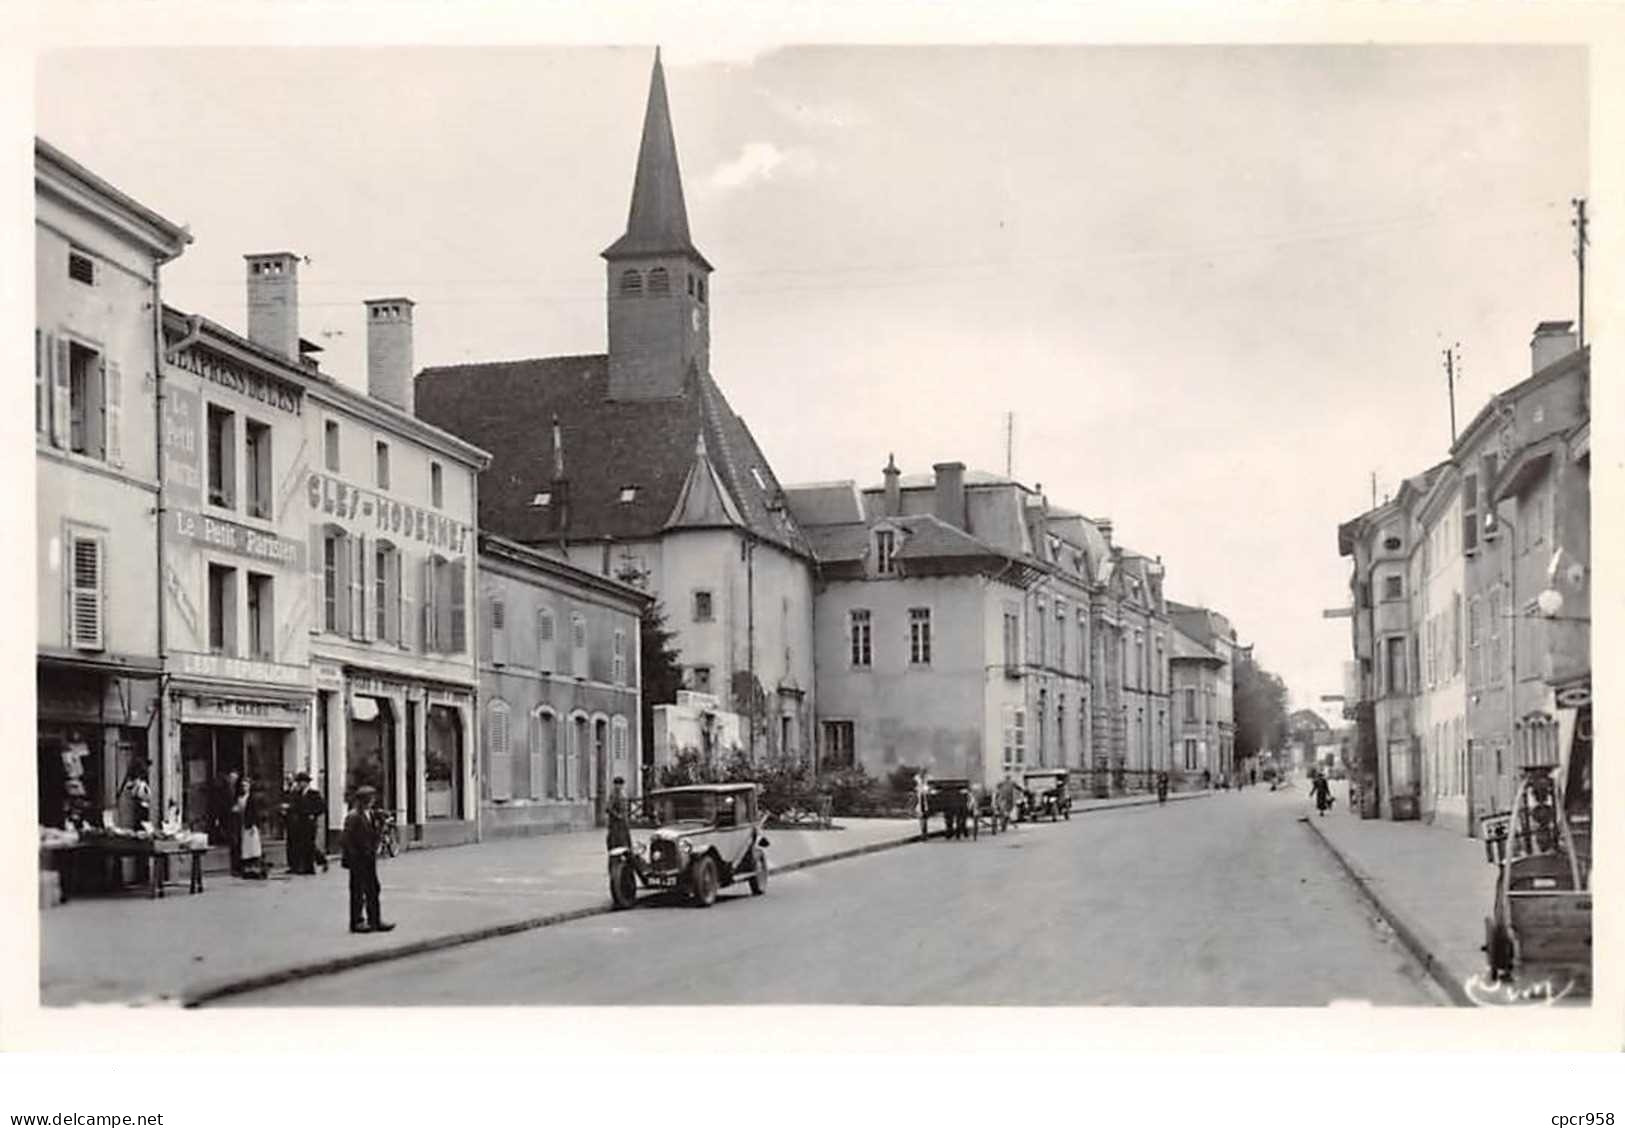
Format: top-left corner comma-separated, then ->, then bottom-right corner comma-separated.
34,662 -> 158,826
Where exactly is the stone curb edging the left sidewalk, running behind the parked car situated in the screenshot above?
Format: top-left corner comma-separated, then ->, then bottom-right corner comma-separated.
179,792 -> 1211,1009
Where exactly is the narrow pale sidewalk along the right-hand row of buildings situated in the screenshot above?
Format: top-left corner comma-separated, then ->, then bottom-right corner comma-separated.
1298,783 -> 1495,1006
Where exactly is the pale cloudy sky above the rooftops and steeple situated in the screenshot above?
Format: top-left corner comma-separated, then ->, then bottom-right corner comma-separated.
36,46 -> 1588,705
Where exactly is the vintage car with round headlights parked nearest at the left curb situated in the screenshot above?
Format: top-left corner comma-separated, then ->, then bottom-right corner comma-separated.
609,783 -> 767,909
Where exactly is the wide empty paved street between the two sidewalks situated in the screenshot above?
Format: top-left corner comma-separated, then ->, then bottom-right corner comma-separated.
234,788 -> 1443,1006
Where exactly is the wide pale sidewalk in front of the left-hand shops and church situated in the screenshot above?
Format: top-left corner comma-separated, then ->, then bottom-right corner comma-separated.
39,792 -> 1206,1006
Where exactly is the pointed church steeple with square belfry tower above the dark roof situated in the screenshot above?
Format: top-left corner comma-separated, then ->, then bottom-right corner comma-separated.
603,49 -> 712,400
